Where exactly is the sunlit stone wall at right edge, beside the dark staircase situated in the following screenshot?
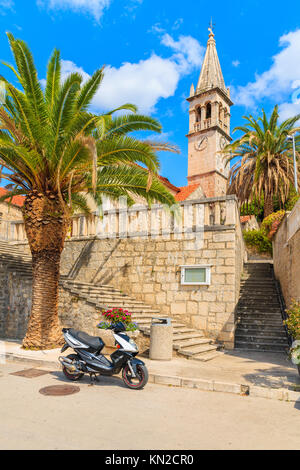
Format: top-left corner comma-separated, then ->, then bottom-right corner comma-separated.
273,200 -> 300,306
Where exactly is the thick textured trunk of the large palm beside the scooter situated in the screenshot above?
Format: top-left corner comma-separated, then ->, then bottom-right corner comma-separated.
23,192 -> 69,349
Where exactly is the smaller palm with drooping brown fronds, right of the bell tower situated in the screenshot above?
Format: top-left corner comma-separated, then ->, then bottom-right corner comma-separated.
224,106 -> 300,217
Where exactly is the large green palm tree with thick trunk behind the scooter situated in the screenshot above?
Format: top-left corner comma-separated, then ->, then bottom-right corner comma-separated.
0,34 -> 175,349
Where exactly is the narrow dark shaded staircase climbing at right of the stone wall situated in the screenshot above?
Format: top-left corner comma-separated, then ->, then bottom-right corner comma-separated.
235,262 -> 289,352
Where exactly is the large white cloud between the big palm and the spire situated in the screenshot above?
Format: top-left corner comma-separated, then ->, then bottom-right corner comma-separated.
58,34 -> 203,114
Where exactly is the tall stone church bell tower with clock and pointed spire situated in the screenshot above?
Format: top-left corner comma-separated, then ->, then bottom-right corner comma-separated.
187,28 -> 233,197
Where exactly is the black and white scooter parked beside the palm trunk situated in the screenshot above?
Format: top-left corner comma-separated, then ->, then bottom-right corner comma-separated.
59,322 -> 148,390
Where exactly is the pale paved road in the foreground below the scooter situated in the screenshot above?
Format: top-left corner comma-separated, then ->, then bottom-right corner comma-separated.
0,363 -> 300,450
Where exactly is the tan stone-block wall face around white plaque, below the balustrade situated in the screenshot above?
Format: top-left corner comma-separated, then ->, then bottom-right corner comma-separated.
61,226 -> 243,348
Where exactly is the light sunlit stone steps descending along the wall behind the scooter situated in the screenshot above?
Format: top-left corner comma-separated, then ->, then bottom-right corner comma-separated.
62,279 -> 219,362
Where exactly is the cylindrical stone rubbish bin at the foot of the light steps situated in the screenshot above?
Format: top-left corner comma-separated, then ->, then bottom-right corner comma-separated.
150,318 -> 173,361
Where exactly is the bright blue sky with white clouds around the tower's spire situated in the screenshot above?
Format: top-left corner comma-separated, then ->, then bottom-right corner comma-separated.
0,0 -> 300,186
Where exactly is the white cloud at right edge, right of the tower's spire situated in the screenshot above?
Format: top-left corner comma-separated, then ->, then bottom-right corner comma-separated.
232,29 -> 300,114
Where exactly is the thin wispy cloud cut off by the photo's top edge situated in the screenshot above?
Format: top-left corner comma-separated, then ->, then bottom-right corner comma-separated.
37,0 -> 111,21
